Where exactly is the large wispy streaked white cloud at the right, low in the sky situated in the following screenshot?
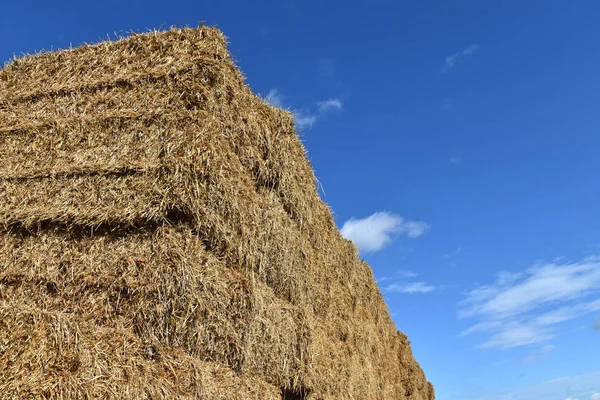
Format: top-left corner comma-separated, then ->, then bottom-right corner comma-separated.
459,257 -> 600,348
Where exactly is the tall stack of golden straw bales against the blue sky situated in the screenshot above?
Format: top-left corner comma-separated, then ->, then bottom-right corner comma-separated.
0,27 -> 434,400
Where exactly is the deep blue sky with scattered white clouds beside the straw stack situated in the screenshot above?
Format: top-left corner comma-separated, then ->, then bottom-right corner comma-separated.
0,0 -> 600,400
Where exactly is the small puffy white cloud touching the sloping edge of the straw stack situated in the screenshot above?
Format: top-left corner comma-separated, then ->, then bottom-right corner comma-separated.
340,211 -> 429,252
